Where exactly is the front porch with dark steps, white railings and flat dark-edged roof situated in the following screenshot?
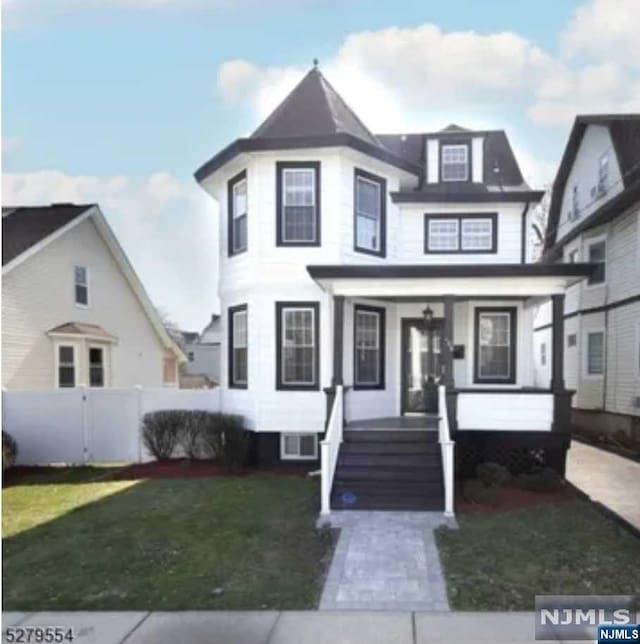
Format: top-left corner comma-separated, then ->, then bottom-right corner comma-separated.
308,264 -> 593,515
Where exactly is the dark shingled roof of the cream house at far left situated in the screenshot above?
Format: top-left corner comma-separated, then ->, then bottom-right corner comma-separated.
2,203 -> 93,266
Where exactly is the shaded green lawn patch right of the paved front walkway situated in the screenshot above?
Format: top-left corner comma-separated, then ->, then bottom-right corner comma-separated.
436,500 -> 640,610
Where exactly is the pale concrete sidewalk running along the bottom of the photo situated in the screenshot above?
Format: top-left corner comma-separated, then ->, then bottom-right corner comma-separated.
2,611 -> 584,644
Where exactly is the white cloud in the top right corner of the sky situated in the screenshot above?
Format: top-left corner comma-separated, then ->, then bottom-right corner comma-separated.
564,0 -> 640,66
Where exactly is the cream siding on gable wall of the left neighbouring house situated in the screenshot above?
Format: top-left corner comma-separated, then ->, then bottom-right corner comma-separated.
2,219 -> 170,389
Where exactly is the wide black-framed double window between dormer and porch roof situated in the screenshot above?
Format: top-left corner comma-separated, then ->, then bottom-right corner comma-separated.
425,213 -> 498,253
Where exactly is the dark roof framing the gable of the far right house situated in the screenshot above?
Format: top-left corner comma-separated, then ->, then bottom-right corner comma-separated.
545,114 -> 640,258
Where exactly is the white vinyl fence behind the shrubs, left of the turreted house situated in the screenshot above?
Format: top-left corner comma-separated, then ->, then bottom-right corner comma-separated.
2,387 -> 220,465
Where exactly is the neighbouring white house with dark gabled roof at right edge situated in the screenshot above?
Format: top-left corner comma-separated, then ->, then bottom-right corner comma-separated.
534,114 -> 640,436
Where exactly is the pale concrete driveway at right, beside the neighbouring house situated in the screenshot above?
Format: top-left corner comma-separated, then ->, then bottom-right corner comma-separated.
567,441 -> 640,530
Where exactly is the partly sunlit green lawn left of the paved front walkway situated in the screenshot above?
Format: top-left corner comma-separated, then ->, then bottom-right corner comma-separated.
2,468 -> 333,611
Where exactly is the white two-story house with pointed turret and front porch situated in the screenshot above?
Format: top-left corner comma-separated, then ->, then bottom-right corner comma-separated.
196,68 -> 591,511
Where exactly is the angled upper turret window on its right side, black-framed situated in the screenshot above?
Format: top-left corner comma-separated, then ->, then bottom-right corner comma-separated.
354,168 -> 387,257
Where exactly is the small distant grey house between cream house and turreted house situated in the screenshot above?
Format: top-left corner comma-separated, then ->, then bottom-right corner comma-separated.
180,313 -> 222,388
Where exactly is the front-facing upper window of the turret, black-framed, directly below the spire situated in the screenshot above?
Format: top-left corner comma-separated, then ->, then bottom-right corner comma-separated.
276,161 -> 320,246
